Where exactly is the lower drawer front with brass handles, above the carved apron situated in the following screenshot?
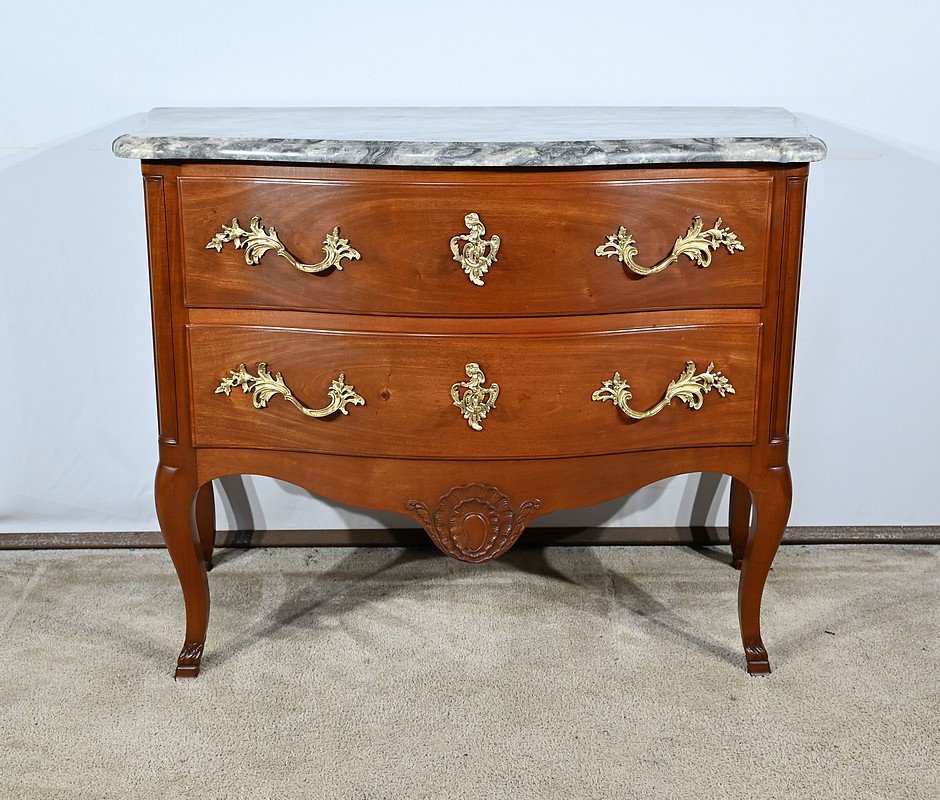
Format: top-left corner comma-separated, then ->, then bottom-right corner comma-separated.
188,324 -> 760,459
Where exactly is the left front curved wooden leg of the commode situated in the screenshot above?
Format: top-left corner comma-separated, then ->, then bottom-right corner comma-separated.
155,463 -> 209,678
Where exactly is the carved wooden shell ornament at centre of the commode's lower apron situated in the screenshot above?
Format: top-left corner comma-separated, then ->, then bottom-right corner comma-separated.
408,483 -> 541,563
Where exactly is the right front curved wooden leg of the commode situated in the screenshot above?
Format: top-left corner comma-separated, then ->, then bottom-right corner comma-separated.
738,467 -> 793,675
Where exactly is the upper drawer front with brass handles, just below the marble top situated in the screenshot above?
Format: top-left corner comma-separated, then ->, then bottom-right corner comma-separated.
179,167 -> 773,316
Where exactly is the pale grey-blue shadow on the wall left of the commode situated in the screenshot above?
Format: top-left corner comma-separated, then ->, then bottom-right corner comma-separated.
0,117 -> 156,533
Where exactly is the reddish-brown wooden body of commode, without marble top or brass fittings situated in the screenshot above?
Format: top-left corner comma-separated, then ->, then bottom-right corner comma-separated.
143,162 -> 808,676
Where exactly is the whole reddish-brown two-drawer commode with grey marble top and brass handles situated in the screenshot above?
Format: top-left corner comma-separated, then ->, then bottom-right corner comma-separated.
114,108 -> 825,676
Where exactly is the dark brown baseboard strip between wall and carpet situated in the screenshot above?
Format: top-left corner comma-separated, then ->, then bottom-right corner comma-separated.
0,525 -> 940,550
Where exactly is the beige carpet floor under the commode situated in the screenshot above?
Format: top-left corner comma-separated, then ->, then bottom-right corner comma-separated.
0,545 -> 940,800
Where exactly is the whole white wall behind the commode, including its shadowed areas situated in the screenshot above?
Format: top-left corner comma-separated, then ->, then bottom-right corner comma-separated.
0,0 -> 940,532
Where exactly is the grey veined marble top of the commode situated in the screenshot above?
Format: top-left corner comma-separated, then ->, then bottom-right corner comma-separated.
113,106 -> 826,167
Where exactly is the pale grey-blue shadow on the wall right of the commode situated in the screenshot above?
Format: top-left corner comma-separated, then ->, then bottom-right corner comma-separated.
790,117 -> 940,525
